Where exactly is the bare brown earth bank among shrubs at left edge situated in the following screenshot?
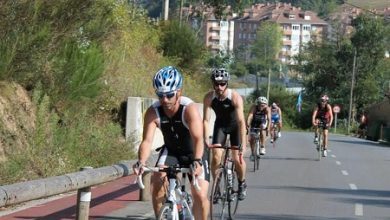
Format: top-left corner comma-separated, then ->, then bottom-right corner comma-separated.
0,81 -> 36,162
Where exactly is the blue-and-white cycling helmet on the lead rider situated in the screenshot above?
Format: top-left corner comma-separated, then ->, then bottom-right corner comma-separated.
153,66 -> 183,93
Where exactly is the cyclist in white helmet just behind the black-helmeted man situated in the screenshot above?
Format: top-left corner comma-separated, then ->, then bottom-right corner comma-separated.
247,96 -> 271,156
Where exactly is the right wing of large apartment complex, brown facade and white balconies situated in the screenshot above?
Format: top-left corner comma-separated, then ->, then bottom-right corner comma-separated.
233,3 -> 328,64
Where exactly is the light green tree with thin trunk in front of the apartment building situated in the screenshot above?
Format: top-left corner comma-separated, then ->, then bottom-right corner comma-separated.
252,21 -> 283,98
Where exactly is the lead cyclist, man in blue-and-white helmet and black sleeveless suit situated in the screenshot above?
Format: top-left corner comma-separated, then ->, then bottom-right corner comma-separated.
133,66 -> 209,220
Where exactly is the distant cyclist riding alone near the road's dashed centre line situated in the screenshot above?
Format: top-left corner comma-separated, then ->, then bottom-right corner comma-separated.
312,95 -> 333,157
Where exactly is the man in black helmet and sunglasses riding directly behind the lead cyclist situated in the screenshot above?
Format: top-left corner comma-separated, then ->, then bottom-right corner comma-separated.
203,68 -> 247,202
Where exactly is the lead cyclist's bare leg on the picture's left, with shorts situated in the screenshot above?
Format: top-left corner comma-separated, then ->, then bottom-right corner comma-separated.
150,147 -> 178,218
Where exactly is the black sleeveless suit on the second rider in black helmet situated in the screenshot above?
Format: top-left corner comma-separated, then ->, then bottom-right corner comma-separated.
211,89 -> 241,146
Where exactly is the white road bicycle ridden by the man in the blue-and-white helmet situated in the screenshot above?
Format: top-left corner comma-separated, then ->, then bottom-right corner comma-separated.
137,165 -> 200,220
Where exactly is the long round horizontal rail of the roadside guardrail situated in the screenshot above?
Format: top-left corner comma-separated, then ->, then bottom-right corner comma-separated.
0,161 -> 134,207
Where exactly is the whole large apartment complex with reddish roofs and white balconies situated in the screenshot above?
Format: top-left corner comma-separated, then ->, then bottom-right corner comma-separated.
183,3 -> 328,64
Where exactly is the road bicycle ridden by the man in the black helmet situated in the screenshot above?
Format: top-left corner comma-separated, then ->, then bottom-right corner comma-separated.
209,144 -> 242,220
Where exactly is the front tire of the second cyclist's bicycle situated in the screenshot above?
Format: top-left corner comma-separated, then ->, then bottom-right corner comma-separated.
210,168 -> 228,220
